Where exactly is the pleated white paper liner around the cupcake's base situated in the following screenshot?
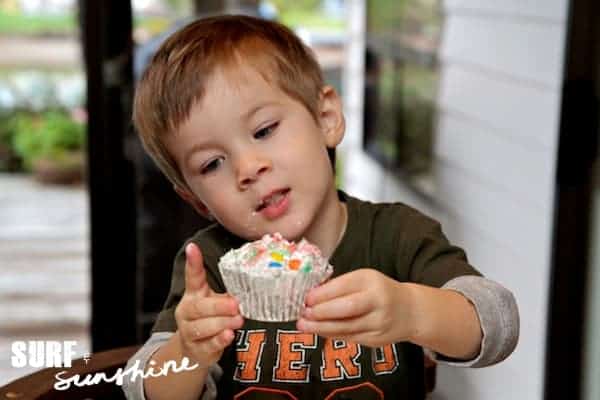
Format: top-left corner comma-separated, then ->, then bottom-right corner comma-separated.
221,268 -> 332,322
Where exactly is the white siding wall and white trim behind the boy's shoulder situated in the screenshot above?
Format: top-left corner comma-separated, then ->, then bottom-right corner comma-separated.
340,0 -> 568,400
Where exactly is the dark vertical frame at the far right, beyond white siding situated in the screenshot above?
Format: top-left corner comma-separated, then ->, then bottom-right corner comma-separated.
544,0 -> 600,400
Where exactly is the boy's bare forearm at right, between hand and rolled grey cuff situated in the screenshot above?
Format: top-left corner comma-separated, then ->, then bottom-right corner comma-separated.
411,284 -> 483,360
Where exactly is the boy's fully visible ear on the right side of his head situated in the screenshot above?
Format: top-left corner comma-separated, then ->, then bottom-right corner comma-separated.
319,85 -> 346,148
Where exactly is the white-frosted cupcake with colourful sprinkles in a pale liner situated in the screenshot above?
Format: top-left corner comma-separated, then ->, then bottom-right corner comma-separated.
219,233 -> 333,322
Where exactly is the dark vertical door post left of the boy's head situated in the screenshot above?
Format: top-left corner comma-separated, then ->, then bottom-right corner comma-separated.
79,0 -> 137,351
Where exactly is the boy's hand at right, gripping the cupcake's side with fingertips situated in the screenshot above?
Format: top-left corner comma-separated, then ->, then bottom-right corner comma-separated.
297,269 -> 417,347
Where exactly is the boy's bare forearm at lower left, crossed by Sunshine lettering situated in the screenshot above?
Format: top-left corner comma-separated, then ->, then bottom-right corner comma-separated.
144,332 -> 208,400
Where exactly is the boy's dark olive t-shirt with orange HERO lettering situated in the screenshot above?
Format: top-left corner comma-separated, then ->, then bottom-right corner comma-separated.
152,191 -> 480,399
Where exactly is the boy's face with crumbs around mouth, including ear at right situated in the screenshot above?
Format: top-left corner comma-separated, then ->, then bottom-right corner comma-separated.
166,68 -> 344,244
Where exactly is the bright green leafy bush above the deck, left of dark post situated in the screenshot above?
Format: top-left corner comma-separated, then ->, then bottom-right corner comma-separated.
10,111 -> 85,170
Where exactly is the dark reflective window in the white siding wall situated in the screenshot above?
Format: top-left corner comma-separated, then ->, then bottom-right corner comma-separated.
363,0 -> 443,193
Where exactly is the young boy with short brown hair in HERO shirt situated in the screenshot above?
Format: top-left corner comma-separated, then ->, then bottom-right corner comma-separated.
124,16 -> 518,400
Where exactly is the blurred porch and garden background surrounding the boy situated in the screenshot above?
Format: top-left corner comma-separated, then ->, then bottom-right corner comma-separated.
0,0 -> 600,400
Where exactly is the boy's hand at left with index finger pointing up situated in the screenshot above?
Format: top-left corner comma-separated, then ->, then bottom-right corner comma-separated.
175,243 -> 244,368
